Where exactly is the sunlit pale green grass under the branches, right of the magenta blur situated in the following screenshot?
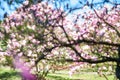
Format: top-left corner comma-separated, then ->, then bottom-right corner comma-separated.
47,71 -> 114,80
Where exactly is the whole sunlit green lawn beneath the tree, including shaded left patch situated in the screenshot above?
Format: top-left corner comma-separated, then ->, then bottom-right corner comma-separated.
0,68 -> 114,80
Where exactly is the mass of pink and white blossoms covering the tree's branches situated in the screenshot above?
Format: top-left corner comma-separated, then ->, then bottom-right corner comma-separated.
0,2 -> 120,76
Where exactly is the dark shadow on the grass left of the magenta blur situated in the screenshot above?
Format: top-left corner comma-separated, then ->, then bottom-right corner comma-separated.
0,71 -> 20,80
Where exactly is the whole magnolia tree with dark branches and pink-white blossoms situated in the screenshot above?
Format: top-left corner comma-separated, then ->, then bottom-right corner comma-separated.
0,2 -> 120,80
